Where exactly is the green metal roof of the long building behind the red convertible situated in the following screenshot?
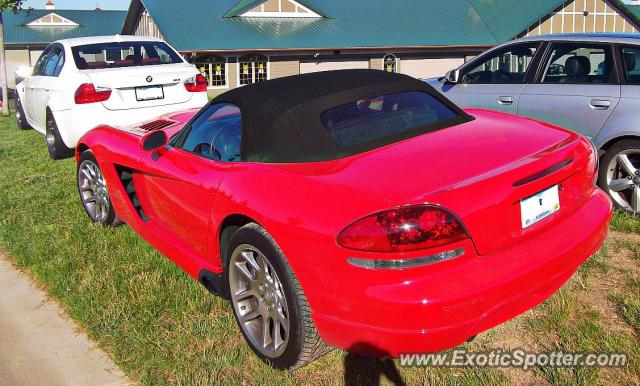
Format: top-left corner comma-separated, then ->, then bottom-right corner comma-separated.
131,0 -> 562,51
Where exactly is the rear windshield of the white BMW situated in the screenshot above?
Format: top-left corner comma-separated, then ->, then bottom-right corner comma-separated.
71,42 -> 183,70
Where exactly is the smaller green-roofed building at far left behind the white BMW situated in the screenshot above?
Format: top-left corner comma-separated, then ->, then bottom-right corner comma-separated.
2,0 -> 127,88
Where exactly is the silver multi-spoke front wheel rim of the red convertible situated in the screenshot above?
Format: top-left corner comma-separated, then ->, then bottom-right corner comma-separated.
78,160 -> 111,223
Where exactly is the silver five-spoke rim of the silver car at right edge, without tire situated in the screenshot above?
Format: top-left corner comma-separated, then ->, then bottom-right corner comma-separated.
607,149 -> 640,213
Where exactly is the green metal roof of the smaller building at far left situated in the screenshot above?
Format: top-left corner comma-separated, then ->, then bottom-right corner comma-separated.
2,9 -> 127,44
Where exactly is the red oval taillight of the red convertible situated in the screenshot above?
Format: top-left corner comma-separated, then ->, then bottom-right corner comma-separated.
338,205 -> 469,252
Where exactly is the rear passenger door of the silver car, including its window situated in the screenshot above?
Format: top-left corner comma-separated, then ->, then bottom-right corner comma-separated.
518,42 -> 620,138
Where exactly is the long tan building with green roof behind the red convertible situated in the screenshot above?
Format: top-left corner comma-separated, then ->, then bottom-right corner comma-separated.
122,0 -> 640,95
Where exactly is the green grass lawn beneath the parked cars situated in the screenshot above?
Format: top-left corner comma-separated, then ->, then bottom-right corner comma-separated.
0,118 -> 640,385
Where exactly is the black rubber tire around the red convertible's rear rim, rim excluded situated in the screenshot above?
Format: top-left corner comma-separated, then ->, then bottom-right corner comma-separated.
225,223 -> 331,370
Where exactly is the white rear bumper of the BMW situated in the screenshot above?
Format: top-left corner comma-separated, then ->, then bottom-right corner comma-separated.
53,93 -> 209,148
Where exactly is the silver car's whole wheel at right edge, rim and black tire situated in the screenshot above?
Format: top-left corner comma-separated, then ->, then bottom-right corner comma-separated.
598,139 -> 640,214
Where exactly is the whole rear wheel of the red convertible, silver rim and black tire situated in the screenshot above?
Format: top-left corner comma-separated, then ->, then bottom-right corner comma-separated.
225,223 -> 330,370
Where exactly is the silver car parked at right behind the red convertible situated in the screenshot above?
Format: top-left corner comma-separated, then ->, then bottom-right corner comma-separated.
427,34 -> 640,213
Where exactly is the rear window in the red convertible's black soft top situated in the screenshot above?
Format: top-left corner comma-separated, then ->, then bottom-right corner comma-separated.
320,91 -> 459,149
